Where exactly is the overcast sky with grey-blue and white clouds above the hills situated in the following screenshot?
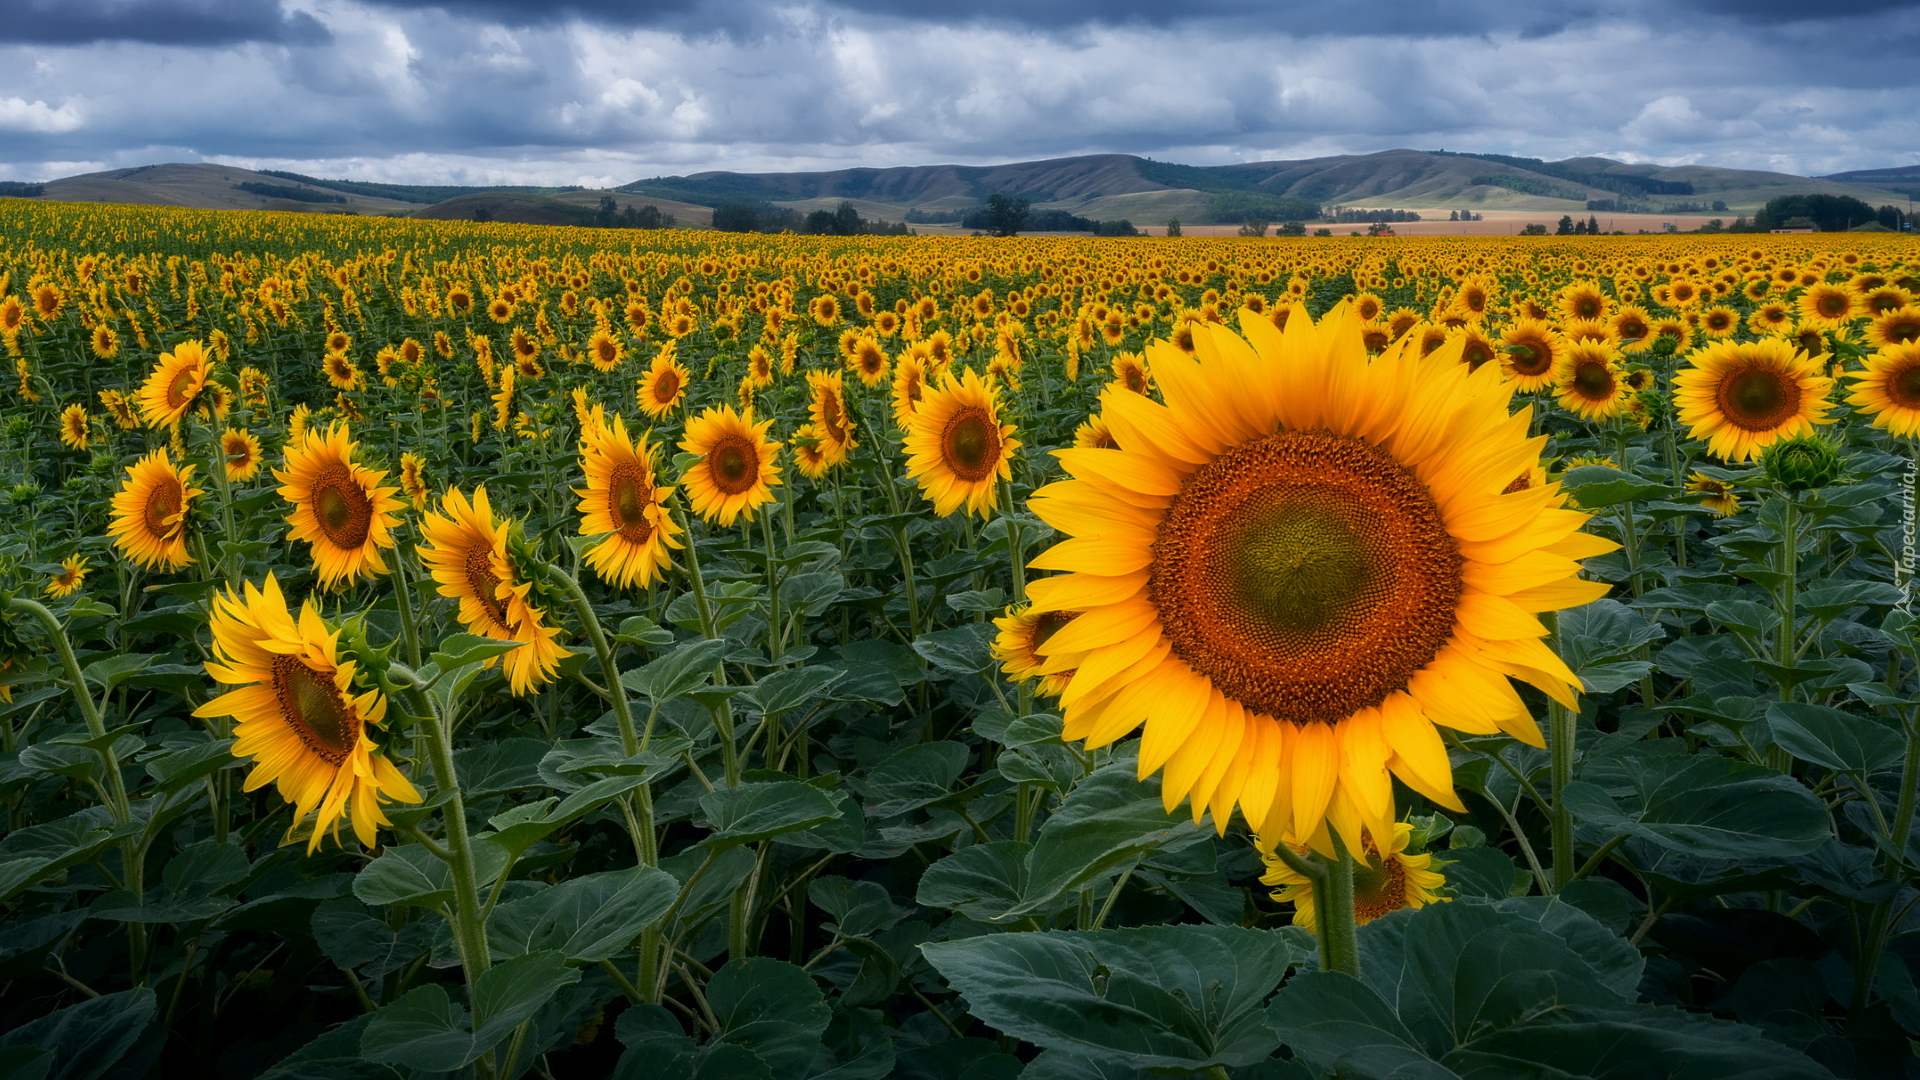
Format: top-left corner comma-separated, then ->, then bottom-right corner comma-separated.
0,0 -> 1920,186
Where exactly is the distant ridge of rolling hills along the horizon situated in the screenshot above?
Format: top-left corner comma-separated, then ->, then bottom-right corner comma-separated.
0,150 -> 1920,225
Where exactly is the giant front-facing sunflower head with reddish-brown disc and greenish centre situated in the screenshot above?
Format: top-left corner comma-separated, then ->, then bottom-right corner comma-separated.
1027,307 -> 1615,853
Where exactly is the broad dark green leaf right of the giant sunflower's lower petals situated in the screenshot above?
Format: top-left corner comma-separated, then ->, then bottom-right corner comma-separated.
1565,753 -> 1832,859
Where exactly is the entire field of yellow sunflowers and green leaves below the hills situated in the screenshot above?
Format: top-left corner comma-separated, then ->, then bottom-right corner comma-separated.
0,200 -> 1920,1080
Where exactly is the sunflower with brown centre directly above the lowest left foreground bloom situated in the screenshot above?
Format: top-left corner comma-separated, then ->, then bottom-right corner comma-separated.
273,423 -> 401,588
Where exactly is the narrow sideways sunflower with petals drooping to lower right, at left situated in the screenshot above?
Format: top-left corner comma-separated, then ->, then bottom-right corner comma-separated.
420,484 -> 563,698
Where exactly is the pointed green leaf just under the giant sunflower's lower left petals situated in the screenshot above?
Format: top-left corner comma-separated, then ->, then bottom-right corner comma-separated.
1006,763 -> 1212,917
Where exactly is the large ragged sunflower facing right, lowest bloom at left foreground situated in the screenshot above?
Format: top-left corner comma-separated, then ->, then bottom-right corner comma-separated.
194,573 -> 420,855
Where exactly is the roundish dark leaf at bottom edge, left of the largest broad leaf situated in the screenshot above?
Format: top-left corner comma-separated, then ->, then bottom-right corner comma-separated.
707,957 -> 833,1080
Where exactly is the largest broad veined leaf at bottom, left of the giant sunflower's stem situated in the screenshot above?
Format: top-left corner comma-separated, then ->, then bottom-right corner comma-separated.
922,914 -> 1304,1072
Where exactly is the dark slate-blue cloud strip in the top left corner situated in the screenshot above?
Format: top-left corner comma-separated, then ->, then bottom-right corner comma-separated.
0,0 -> 326,46
